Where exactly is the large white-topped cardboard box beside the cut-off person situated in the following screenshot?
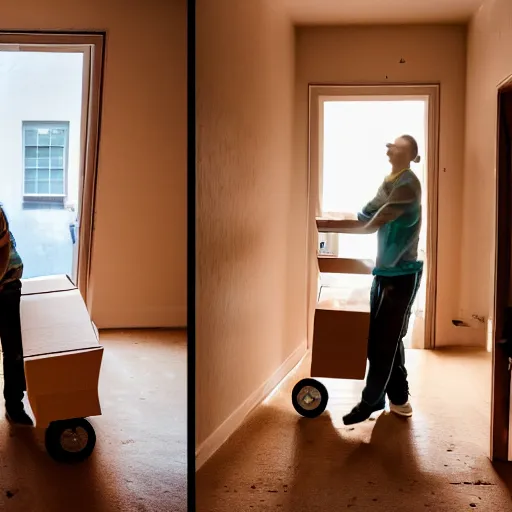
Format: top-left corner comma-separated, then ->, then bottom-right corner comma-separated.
21,276 -> 103,428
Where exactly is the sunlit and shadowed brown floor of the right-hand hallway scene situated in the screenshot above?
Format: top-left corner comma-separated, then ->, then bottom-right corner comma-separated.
197,350 -> 512,512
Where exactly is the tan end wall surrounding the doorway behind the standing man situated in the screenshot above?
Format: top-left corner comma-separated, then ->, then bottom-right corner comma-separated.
295,25 -> 478,346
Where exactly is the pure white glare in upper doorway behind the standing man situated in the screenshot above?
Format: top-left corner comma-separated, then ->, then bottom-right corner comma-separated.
322,100 -> 427,260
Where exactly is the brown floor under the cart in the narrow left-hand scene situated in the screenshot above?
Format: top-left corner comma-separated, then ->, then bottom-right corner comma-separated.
0,331 -> 187,512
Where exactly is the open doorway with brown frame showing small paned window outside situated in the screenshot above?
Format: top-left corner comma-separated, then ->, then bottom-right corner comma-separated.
0,33 -> 104,299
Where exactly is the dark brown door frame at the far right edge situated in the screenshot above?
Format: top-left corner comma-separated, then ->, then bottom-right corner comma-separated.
490,75 -> 512,461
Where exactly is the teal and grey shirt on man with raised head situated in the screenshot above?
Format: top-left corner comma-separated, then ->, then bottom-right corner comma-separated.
358,169 -> 423,276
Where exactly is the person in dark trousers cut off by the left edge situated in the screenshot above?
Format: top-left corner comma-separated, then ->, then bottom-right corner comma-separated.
0,206 -> 33,425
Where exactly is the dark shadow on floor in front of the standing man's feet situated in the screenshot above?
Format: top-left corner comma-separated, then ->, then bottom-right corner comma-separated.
284,413 -> 458,512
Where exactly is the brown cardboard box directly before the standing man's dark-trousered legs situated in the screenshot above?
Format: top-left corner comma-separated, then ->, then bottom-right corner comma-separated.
311,289 -> 370,380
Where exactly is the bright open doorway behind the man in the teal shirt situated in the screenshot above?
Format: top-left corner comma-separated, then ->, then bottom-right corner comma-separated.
319,96 -> 428,348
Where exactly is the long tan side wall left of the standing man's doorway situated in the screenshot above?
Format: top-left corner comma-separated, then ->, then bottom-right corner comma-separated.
196,0 -> 300,445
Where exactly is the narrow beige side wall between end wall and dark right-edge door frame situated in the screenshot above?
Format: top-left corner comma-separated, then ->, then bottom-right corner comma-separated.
461,0 -> 512,344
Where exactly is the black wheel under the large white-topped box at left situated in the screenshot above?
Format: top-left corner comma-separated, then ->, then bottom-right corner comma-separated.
45,418 -> 96,463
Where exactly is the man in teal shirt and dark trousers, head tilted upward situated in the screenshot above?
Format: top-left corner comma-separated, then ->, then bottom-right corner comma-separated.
343,135 -> 423,425
